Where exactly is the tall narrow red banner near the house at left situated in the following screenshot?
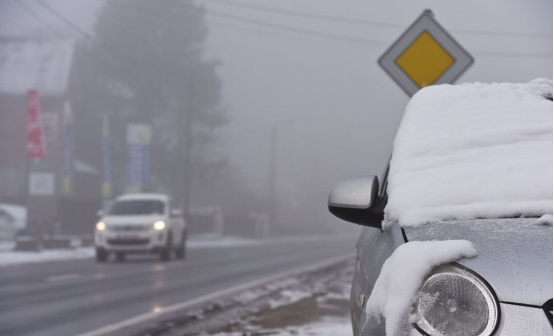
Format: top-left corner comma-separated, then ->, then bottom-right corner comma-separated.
27,90 -> 46,159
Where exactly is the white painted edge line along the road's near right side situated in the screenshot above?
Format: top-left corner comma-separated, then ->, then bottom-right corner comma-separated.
77,253 -> 354,336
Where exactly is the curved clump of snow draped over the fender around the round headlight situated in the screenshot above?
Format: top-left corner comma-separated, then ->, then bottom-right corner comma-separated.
366,240 -> 477,336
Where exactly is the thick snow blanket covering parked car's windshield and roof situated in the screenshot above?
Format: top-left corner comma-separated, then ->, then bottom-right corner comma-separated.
384,79 -> 552,227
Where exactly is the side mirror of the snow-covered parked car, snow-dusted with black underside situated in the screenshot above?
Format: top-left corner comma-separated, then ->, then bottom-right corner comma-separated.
328,175 -> 386,229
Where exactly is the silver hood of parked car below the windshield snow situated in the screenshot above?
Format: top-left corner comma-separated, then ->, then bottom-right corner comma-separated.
405,218 -> 553,306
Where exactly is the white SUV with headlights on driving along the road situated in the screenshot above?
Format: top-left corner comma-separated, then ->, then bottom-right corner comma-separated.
94,194 -> 187,262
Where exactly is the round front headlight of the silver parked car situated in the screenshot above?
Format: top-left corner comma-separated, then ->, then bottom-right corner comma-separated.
414,264 -> 500,336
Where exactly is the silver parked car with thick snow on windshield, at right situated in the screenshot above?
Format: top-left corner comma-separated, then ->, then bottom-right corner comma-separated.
329,79 -> 553,336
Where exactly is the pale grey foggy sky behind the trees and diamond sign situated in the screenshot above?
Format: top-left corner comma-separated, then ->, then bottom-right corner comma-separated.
0,0 -> 552,226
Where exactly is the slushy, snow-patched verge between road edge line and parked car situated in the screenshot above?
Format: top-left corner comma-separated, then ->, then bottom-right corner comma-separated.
162,262 -> 354,336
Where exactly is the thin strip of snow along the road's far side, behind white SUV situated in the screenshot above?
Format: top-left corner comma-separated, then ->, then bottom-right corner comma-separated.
0,235 -> 344,267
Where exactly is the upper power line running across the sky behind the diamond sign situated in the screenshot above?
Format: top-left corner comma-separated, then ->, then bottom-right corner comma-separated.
206,0 -> 552,38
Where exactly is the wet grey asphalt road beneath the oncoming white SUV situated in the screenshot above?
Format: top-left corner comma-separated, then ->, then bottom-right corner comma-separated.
0,237 -> 355,336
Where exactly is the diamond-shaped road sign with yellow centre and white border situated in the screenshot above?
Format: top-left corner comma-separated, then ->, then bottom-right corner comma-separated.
378,10 -> 473,96
